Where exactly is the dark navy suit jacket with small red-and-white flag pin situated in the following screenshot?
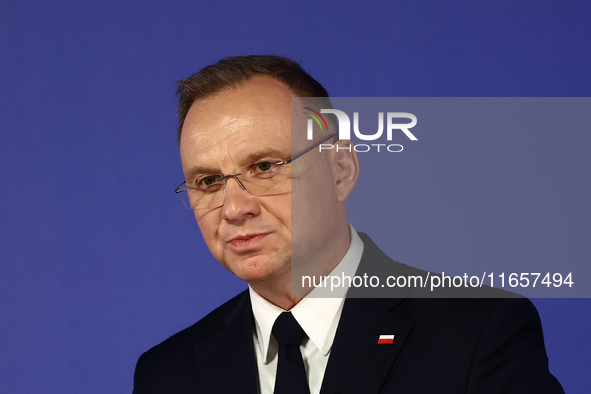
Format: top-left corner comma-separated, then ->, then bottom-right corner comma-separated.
134,234 -> 564,394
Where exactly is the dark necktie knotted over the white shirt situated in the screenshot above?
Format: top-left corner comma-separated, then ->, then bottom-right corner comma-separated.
271,312 -> 310,394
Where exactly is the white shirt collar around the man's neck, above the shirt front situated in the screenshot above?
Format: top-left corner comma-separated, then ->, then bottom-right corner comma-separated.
248,225 -> 363,364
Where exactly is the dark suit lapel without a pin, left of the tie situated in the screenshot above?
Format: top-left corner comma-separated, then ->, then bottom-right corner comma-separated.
195,293 -> 258,394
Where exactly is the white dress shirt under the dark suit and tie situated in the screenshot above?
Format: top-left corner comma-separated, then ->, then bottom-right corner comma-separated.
248,226 -> 363,394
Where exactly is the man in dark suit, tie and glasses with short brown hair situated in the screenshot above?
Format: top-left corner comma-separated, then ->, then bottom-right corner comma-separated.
134,56 -> 563,394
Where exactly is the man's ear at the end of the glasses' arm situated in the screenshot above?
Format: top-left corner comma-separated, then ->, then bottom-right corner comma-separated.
331,140 -> 359,202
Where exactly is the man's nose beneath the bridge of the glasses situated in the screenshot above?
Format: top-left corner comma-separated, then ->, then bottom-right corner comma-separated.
222,176 -> 261,222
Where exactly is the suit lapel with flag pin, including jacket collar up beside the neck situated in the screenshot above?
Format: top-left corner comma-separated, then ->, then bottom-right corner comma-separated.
321,233 -> 414,394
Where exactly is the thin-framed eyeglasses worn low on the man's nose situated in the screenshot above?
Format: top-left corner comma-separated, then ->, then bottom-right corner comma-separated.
175,133 -> 338,210
